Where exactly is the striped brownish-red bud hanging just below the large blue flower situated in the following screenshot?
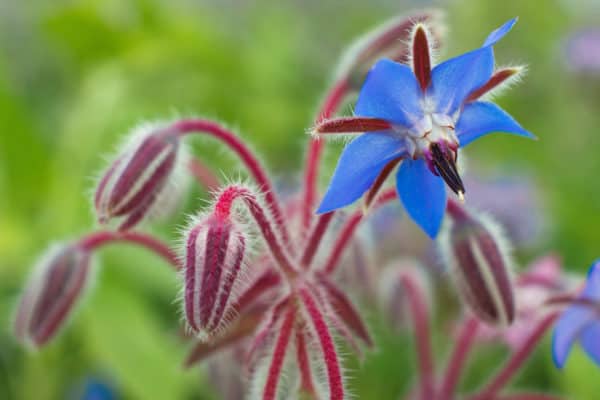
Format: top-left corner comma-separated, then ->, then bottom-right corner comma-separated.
440,203 -> 515,326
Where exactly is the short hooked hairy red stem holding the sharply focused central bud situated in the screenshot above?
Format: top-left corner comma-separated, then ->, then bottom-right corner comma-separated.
214,185 -> 296,277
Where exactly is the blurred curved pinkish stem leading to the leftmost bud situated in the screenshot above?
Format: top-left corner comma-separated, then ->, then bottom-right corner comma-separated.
78,231 -> 182,270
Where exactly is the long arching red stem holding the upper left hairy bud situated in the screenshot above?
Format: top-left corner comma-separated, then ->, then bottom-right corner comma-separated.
170,119 -> 292,251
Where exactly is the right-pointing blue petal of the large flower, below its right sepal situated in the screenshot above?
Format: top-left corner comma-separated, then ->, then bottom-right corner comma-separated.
456,101 -> 535,146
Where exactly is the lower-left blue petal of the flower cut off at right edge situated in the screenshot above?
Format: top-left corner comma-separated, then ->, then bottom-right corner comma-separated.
552,305 -> 595,368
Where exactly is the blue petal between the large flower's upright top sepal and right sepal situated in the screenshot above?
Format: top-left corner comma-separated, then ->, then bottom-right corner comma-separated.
429,46 -> 494,115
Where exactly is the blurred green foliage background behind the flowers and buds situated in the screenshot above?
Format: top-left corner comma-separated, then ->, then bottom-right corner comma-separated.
0,0 -> 600,399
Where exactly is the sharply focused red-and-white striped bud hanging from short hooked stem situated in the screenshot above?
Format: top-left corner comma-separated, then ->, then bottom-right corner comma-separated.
183,213 -> 246,340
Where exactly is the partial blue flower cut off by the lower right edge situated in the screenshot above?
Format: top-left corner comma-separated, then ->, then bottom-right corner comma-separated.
552,259 -> 600,368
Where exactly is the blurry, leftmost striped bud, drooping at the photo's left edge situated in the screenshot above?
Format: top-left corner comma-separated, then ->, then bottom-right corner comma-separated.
14,244 -> 90,347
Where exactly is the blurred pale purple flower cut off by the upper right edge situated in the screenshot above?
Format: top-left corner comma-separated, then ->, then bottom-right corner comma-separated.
564,27 -> 600,74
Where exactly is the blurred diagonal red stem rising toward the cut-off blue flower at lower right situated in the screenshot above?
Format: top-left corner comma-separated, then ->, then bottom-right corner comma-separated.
471,312 -> 559,400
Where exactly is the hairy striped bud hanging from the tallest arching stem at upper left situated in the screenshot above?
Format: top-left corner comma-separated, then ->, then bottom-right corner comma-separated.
94,125 -> 184,230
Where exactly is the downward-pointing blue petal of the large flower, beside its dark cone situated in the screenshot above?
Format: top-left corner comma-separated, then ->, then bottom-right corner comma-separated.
396,159 -> 446,239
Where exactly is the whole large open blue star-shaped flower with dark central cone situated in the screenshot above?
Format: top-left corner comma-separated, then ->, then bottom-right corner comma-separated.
317,18 -> 534,238
